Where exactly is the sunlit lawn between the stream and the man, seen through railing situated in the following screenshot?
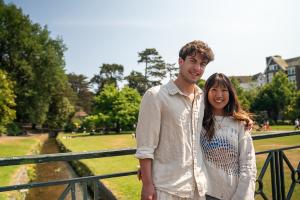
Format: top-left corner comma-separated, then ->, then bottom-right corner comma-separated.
58,134 -> 141,200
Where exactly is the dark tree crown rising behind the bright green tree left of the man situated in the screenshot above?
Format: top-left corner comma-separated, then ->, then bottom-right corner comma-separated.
91,64 -> 124,93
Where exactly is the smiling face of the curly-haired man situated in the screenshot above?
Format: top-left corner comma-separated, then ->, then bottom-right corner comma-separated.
178,53 -> 207,84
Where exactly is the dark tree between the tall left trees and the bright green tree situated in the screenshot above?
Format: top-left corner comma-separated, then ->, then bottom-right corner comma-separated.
68,73 -> 93,113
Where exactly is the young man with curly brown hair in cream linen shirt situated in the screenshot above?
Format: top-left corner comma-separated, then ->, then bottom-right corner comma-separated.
136,41 -> 214,200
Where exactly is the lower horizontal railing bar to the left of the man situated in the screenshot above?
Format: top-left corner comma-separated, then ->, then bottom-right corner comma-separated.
0,171 -> 137,192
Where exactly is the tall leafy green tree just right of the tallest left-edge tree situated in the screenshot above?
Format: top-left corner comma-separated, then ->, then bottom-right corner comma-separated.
28,37 -> 69,125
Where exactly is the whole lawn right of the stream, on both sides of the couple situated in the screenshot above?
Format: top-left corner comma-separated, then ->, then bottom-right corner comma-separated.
58,131 -> 300,200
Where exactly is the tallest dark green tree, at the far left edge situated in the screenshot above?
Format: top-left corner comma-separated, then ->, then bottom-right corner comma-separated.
0,1 -> 39,121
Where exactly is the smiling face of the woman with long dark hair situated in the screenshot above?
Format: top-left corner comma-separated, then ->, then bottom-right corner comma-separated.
208,83 -> 229,116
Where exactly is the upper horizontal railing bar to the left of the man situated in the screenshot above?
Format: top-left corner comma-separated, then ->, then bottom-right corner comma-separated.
0,148 -> 136,166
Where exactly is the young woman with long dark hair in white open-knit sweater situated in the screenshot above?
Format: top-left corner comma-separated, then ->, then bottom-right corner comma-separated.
200,73 -> 256,200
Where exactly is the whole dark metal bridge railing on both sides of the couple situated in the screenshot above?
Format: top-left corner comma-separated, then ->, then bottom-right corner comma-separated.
0,131 -> 300,200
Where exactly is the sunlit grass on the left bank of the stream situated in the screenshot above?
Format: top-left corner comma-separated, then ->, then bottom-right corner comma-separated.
0,136 -> 42,200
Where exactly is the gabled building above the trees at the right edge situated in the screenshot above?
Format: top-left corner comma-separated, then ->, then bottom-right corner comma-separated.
264,55 -> 300,90
